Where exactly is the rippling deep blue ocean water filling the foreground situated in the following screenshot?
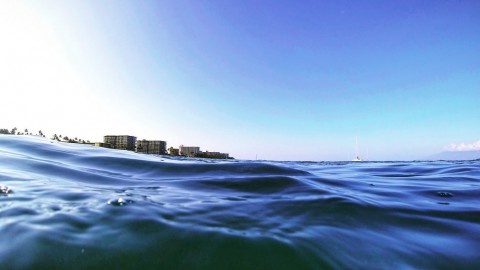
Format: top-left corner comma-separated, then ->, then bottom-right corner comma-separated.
0,135 -> 480,269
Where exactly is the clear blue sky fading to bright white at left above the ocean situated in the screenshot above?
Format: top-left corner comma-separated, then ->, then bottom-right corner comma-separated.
0,0 -> 480,160
